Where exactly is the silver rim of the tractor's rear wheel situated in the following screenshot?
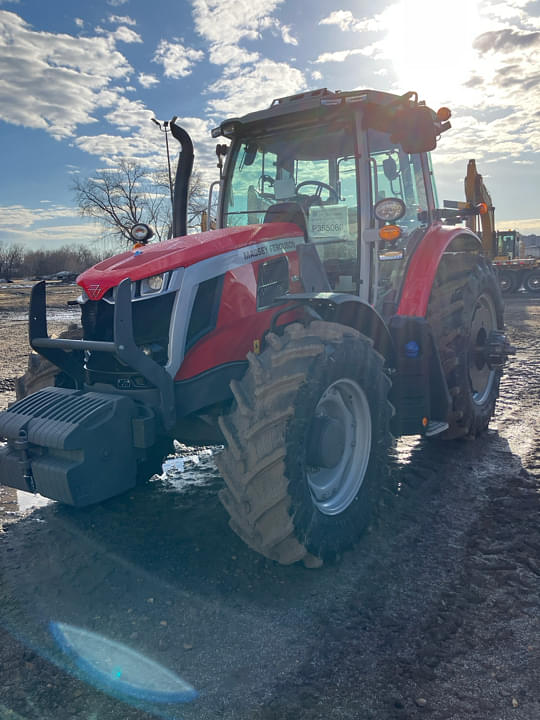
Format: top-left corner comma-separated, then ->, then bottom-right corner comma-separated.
469,295 -> 497,405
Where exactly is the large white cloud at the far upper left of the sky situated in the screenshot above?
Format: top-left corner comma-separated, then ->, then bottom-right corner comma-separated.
0,11 -> 132,139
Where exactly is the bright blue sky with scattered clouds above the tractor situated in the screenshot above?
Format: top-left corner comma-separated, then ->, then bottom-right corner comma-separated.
0,0 -> 540,249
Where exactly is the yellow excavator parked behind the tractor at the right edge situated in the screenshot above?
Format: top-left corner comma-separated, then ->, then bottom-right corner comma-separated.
465,160 -> 540,294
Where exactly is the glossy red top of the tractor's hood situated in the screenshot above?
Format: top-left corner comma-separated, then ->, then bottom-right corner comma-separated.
77,222 -> 303,300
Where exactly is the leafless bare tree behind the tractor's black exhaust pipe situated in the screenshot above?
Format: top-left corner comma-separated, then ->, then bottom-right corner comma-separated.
73,160 -> 209,244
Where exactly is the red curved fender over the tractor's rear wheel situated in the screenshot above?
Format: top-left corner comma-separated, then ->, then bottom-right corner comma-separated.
397,223 -> 482,317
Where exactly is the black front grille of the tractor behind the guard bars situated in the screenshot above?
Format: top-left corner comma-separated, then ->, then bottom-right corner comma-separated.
82,293 -> 175,386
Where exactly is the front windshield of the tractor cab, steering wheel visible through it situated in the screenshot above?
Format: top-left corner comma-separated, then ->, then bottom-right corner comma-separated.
222,121 -> 358,292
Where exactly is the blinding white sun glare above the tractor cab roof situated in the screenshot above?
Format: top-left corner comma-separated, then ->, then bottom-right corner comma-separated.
383,0 -> 482,104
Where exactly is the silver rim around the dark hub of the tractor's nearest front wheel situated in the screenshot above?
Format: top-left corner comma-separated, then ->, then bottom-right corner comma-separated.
306,378 -> 371,515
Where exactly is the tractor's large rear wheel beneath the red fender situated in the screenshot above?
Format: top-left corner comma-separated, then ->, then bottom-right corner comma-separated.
427,254 -> 503,439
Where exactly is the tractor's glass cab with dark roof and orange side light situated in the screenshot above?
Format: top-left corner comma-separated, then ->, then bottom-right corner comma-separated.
213,90 -> 449,315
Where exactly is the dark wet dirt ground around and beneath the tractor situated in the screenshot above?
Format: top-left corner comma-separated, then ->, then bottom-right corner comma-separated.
0,287 -> 540,720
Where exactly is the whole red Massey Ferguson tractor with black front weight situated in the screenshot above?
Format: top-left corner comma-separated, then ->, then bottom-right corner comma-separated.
0,90 -> 511,565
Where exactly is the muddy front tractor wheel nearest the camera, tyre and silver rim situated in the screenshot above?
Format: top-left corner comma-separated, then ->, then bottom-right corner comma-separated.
216,322 -> 392,566
